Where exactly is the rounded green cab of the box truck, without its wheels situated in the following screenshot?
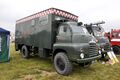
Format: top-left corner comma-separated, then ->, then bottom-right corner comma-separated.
54,21 -> 99,63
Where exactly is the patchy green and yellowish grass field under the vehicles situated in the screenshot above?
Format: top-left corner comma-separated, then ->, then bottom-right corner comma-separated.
0,44 -> 120,80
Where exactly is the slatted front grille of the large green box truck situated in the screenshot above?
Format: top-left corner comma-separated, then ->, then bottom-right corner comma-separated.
89,43 -> 98,57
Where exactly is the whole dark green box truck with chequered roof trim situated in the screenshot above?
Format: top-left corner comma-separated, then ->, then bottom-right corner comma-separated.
15,8 -> 101,75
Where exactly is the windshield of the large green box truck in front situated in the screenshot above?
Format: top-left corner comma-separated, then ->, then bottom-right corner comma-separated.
72,25 -> 90,35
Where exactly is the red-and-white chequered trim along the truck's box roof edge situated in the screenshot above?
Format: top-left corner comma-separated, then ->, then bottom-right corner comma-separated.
16,8 -> 78,24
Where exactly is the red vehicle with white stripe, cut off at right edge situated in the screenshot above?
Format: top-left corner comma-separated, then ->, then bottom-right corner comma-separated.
107,29 -> 120,54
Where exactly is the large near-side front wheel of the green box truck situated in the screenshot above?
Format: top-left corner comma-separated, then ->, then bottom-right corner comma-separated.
54,52 -> 72,75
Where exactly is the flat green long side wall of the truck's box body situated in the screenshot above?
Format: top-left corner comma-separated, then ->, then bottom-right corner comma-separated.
15,15 -> 52,49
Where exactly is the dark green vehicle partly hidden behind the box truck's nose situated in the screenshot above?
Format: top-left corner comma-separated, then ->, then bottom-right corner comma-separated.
85,21 -> 111,58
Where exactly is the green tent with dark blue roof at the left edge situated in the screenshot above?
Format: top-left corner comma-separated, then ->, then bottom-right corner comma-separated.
0,28 -> 10,62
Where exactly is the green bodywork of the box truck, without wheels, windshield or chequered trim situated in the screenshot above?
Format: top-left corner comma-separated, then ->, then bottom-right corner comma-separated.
15,14 -> 100,63
